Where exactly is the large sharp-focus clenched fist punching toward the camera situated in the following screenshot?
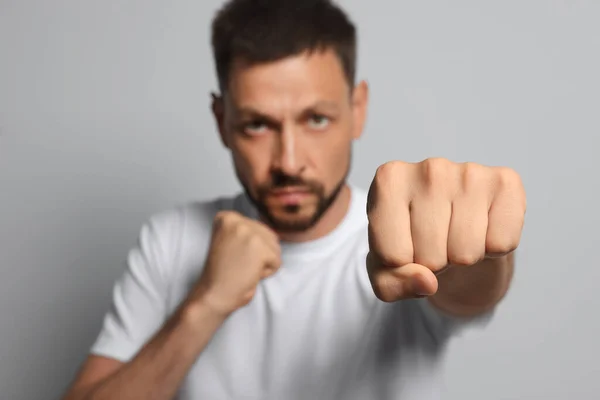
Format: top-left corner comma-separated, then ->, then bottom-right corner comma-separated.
367,158 -> 526,301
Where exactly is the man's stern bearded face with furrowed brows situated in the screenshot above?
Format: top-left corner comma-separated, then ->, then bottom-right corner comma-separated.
213,51 -> 367,232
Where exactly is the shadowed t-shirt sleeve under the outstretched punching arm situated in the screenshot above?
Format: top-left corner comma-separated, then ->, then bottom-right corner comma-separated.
414,298 -> 495,342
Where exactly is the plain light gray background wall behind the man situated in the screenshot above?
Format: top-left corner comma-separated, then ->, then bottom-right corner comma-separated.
0,0 -> 600,400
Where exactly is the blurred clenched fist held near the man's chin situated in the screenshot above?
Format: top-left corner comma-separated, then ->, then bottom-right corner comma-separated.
192,211 -> 281,315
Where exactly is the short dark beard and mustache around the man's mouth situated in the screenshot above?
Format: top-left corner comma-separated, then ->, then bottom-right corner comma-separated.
238,163 -> 350,233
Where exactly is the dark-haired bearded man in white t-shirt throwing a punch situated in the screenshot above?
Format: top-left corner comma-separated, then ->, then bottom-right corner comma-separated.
66,0 -> 525,400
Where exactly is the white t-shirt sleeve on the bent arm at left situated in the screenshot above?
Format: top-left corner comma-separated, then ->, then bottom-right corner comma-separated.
91,211 -> 176,362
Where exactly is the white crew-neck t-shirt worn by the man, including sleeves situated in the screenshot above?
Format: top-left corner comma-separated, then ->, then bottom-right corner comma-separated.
92,186 -> 491,400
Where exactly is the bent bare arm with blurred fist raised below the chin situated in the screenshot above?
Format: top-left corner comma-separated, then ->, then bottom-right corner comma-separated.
64,212 -> 281,400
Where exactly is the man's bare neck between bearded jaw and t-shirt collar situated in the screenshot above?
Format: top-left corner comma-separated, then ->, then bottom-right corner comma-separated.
277,184 -> 351,242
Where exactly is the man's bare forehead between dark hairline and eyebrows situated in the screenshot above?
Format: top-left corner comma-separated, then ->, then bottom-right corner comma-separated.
228,50 -> 350,112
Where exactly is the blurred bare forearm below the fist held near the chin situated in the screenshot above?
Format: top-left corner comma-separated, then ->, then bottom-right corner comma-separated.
85,296 -> 226,400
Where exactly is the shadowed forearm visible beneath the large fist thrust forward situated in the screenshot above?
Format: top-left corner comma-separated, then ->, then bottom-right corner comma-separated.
429,253 -> 515,316
